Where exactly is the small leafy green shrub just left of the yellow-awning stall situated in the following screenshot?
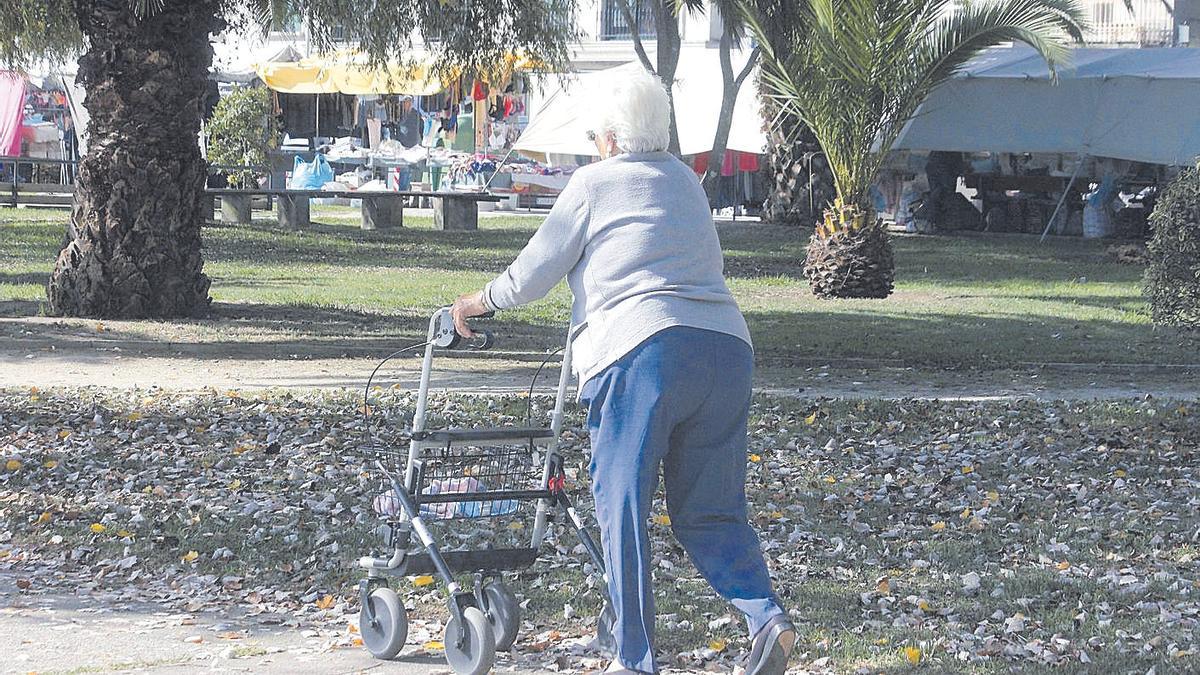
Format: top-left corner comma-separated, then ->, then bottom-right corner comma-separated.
208,86 -> 280,187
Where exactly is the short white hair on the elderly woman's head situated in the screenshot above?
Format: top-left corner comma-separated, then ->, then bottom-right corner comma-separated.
593,68 -> 671,153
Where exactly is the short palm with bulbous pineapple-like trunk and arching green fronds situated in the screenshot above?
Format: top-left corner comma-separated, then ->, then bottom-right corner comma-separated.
743,0 -> 1084,298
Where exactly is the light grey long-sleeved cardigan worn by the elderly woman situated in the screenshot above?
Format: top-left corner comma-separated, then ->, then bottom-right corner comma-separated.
484,153 -> 750,384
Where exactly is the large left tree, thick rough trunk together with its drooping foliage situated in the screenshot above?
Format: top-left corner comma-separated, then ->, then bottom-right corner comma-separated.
0,0 -> 576,318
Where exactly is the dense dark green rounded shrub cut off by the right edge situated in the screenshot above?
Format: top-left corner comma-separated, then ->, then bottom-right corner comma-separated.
1145,168 -> 1200,328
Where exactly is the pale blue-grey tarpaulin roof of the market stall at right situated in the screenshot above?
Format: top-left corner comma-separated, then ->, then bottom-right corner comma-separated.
895,46 -> 1200,165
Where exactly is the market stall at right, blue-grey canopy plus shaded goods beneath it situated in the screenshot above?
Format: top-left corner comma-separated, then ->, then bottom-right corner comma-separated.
895,47 -> 1200,235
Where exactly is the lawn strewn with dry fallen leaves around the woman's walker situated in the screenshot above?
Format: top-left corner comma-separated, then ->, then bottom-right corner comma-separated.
0,389 -> 1200,674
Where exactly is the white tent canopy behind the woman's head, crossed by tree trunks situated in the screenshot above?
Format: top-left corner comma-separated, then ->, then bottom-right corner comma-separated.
514,49 -> 767,156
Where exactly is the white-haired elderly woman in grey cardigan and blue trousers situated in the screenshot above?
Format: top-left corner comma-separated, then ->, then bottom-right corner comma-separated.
451,71 -> 796,675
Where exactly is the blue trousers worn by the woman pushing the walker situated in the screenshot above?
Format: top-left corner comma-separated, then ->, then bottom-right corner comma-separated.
580,327 -> 784,673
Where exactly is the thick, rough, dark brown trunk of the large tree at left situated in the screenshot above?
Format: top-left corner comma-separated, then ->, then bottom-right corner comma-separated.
47,0 -> 224,318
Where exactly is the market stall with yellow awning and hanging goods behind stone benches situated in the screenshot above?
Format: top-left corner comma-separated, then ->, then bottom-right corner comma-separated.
250,52 -> 536,200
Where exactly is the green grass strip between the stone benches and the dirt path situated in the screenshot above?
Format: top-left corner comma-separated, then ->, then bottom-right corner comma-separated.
0,207 -> 1196,368
